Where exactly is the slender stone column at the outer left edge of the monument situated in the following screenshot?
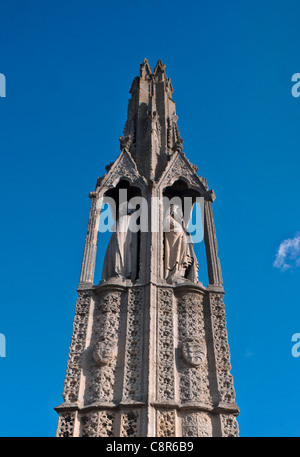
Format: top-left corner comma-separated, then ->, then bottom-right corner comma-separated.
79,192 -> 100,288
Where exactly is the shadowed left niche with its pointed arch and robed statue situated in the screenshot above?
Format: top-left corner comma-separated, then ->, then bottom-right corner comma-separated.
101,180 -> 141,282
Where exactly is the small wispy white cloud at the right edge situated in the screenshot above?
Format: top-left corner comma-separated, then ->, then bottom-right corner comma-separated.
273,232 -> 300,271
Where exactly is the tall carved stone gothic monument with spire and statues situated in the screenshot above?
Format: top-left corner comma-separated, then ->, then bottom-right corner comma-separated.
55,59 -> 239,437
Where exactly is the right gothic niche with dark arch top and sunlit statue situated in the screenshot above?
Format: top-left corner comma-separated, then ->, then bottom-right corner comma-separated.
163,180 -> 200,283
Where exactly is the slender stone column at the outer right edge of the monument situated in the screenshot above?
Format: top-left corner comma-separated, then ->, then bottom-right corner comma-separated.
204,190 -> 223,288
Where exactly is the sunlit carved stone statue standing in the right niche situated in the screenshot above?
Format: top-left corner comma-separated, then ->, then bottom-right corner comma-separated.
164,205 -> 198,282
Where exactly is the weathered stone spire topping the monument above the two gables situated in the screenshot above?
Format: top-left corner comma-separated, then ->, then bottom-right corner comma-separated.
124,59 -> 183,181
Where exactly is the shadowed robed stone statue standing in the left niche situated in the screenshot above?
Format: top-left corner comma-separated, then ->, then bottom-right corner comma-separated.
102,202 -> 138,281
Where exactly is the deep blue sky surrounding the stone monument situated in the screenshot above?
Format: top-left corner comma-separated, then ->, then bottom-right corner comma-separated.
0,0 -> 300,436
